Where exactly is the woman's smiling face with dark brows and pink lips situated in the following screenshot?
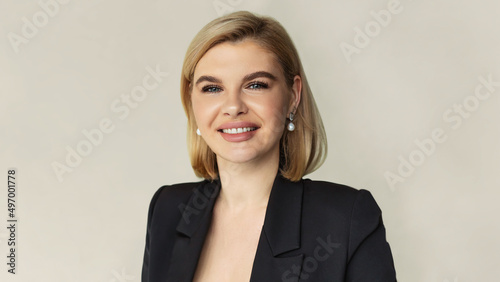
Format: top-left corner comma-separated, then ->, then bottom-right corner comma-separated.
191,40 -> 301,167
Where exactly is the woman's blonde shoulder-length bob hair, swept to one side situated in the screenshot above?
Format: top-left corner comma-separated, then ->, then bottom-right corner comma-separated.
181,11 -> 327,181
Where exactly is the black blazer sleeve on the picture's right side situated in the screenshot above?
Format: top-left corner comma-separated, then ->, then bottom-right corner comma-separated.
346,190 -> 397,282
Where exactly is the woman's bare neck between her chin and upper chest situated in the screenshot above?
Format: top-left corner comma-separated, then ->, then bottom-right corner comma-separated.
217,153 -> 279,212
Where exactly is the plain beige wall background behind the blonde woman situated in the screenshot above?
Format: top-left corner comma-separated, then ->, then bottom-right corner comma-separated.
0,0 -> 500,282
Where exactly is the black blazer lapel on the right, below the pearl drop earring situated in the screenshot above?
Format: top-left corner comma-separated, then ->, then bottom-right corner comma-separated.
250,173 -> 304,282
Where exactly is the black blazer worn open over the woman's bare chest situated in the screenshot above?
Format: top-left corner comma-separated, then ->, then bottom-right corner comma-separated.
142,174 -> 396,282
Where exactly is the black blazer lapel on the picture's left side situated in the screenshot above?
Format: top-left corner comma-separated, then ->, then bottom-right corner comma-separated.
166,180 -> 220,282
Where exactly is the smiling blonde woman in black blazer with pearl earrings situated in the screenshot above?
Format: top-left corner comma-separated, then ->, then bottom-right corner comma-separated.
142,12 -> 396,282
